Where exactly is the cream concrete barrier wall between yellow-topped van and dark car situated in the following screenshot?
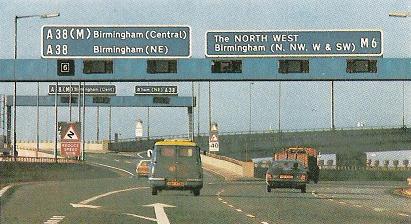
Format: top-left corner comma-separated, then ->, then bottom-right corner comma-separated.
201,153 -> 254,178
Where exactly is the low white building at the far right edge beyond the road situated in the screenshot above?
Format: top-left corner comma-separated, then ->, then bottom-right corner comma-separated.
365,150 -> 411,167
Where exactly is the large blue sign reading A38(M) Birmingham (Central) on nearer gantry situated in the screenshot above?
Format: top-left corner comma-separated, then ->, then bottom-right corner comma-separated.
41,25 -> 191,58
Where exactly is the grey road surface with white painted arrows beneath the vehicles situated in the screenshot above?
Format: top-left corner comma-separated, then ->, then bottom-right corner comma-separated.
1,154 -> 411,224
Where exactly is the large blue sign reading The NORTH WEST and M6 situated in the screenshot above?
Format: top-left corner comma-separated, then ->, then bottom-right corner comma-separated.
205,30 -> 383,57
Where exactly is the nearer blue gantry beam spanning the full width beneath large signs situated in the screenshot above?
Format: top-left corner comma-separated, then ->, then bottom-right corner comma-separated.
0,57 -> 411,82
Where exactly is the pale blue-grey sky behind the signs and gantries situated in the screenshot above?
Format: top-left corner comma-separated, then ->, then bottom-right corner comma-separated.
0,0 -> 411,140
